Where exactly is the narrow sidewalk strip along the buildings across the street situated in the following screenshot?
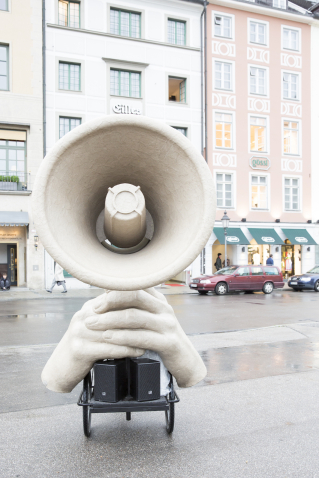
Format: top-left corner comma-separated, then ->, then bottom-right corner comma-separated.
0,285 -> 197,302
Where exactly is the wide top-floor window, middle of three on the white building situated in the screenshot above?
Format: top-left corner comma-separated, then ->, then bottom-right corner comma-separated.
110,8 -> 141,38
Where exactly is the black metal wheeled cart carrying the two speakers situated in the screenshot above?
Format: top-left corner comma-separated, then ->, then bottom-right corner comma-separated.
77,359 -> 180,438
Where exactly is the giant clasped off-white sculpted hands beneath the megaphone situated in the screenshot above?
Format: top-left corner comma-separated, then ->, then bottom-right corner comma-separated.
42,288 -> 207,393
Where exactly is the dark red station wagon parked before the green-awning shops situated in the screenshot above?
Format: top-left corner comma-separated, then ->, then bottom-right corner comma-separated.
189,265 -> 284,295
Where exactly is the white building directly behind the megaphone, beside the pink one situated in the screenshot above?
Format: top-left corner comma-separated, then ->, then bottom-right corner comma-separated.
45,0 -> 203,287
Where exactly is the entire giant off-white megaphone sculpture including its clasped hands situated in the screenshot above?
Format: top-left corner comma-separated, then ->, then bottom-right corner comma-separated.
33,115 -> 216,392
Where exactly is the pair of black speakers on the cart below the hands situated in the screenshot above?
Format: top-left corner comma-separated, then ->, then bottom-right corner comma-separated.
94,358 -> 161,403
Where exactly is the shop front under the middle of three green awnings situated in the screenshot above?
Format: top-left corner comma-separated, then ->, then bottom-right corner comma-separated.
248,227 -> 284,267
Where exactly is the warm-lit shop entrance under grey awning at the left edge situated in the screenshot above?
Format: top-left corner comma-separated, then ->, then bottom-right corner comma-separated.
0,211 -> 29,286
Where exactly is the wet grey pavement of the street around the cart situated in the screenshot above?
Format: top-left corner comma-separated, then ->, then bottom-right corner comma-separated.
0,291 -> 319,478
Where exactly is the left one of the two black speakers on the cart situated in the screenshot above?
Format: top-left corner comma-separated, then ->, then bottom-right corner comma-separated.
94,359 -> 128,403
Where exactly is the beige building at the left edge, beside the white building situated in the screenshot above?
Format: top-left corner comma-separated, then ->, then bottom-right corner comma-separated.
0,0 -> 44,288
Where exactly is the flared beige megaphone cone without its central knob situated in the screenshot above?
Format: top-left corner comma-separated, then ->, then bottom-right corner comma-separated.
32,115 -> 216,290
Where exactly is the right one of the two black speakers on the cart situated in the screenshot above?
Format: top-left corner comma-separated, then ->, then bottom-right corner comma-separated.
130,358 -> 161,402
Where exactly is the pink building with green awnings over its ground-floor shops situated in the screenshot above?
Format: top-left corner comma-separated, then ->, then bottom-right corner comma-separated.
206,0 -> 319,276
